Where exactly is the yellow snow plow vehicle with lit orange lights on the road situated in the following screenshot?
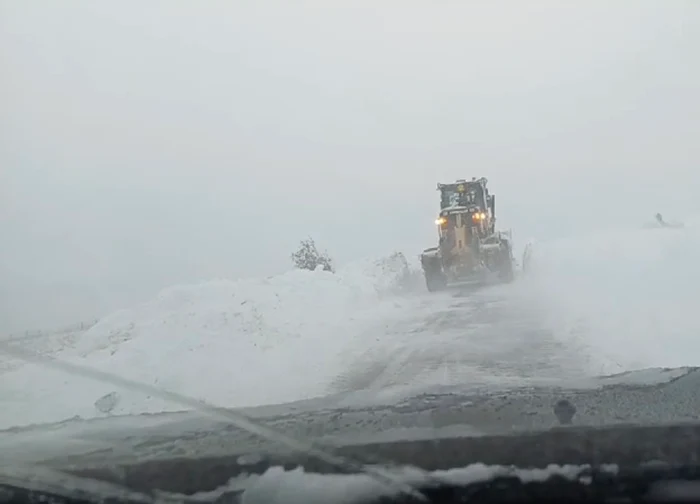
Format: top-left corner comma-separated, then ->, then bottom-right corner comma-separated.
421,177 -> 514,292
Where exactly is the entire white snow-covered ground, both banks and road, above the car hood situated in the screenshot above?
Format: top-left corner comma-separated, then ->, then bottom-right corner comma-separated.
0,217 -> 700,428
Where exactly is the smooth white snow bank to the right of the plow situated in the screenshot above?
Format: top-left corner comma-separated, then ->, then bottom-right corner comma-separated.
516,219 -> 700,373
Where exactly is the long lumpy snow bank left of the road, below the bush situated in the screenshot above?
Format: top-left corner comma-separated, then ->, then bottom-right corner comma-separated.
0,254 -> 422,427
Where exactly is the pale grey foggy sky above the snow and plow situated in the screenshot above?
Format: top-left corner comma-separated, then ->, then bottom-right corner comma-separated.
0,0 -> 700,333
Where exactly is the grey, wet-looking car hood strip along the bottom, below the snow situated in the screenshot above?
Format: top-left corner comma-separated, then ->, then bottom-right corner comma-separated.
0,368 -> 700,467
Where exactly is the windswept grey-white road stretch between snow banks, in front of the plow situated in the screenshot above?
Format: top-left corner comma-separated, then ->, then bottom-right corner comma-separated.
329,288 -> 590,398
